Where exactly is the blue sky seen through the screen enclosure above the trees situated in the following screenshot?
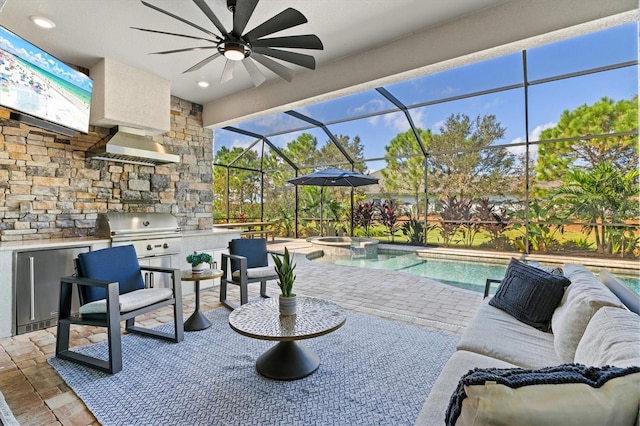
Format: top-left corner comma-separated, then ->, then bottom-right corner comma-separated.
214,23 -> 638,171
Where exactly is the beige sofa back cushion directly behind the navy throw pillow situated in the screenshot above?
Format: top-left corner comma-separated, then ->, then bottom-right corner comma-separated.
551,264 -> 623,363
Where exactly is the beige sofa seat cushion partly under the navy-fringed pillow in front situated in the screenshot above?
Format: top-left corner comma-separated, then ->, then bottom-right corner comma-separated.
414,351 -> 515,426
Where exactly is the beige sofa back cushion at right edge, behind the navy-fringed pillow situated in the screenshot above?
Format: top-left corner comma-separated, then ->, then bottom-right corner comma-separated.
575,307 -> 640,367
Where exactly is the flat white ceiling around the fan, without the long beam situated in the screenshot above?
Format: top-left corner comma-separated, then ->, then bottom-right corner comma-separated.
0,0 -> 506,105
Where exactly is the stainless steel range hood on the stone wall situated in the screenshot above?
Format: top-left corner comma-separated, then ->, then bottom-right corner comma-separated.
87,126 -> 180,166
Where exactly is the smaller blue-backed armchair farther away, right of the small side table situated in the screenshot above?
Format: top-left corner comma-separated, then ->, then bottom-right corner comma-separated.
220,238 -> 278,309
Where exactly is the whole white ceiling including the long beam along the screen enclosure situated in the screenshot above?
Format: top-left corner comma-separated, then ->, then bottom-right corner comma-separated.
0,0 -> 638,128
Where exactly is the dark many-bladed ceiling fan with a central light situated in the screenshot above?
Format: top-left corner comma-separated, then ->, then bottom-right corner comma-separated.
131,0 -> 324,87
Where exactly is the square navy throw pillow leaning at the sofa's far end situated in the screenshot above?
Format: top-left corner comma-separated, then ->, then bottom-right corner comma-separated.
489,259 -> 571,332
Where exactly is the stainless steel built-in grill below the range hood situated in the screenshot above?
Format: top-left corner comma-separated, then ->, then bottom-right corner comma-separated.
96,213 -> 182,287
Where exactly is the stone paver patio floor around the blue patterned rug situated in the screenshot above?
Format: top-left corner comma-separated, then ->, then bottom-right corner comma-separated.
0,240 -> 482,426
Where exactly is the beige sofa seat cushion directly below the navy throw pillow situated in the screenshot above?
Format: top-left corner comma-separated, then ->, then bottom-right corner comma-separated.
458,301 -> 561,368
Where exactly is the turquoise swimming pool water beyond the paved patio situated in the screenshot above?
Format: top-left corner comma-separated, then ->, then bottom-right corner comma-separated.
313,250 -> 640,294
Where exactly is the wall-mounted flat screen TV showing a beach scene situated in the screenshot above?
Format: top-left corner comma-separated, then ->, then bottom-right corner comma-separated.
0,26 -> 93,136
